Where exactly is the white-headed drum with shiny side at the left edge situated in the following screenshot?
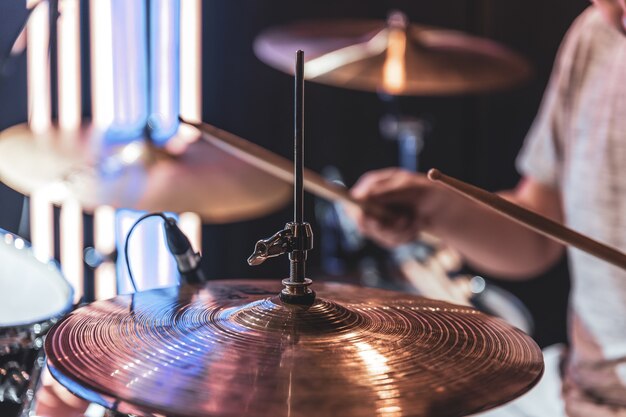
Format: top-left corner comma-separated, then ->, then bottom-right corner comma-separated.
0,229 -> 73,416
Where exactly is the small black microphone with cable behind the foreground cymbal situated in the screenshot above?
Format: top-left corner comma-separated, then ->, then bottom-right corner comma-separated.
163,217 -> 206,284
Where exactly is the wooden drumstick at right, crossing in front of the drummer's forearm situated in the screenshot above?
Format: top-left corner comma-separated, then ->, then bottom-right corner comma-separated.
428,169 -> 626,269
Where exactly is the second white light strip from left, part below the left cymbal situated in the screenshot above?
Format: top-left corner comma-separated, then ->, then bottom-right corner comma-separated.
59,198 -> 85,302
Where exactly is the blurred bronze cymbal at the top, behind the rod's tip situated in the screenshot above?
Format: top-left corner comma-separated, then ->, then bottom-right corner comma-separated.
254,12 -> 531,96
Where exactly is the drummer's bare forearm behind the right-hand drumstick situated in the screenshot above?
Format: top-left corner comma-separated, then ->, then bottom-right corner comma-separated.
433,177 -> 563,279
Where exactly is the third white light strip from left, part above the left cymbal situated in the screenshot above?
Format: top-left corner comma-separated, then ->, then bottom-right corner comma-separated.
89,0 -> 113,129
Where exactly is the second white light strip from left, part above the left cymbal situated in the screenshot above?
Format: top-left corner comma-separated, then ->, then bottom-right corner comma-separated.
57,0 -> 81,130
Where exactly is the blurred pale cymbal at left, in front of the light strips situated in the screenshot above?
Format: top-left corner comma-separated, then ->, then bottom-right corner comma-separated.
0,125 -> 291,223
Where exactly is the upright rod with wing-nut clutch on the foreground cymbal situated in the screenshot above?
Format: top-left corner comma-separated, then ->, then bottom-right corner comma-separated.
248,50 -> 315,305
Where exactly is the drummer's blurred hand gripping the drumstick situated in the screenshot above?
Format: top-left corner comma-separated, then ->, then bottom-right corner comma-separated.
346,168 -> 445,247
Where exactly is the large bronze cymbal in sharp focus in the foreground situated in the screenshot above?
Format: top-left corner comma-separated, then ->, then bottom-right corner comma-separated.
45,280 -> 543,417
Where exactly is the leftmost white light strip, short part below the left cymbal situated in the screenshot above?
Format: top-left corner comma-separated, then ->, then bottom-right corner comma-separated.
30,189 -> 54,262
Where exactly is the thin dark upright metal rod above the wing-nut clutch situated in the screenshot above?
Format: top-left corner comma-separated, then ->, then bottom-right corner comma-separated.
293,50 -> 304,224
